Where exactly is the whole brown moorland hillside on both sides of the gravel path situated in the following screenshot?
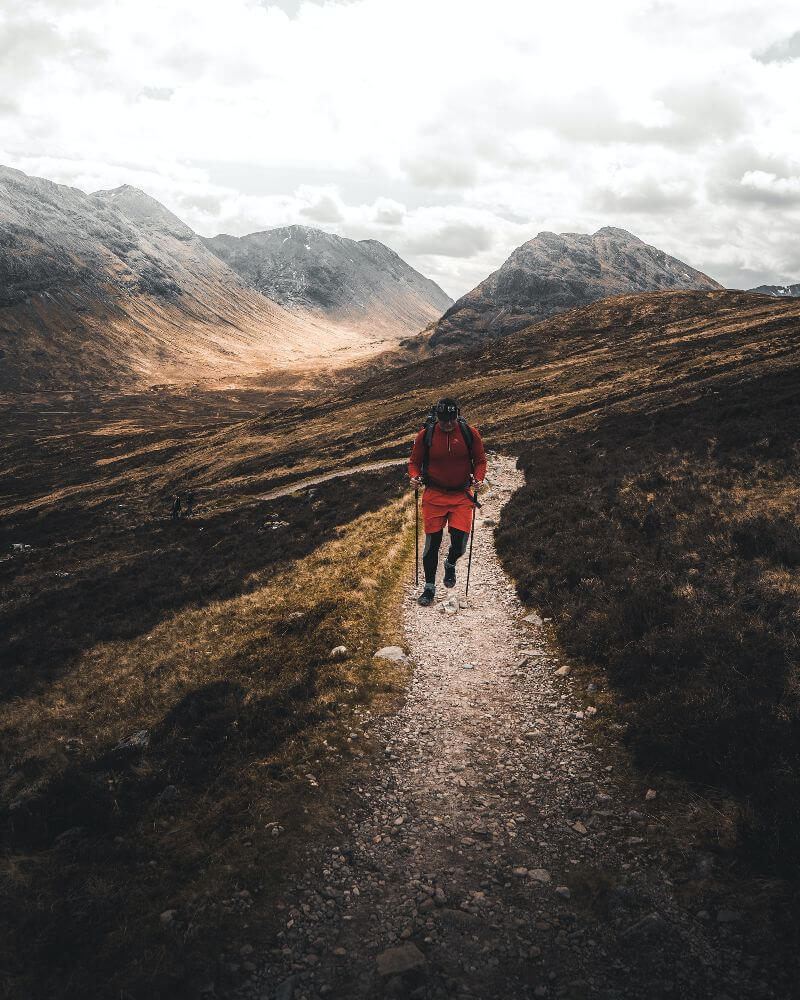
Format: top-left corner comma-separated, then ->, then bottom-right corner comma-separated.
0,291 -> 800,998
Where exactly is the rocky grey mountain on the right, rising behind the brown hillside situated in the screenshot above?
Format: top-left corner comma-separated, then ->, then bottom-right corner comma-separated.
418,226 -> 722,349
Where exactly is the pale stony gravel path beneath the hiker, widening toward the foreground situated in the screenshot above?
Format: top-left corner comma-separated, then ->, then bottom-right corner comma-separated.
244,455 -> 778,1000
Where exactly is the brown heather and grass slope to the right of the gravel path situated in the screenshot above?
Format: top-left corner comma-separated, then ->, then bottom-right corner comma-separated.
166,291 -> 800,872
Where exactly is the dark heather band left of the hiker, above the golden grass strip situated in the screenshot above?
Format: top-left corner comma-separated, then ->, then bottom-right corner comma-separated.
0,469 -> 403,698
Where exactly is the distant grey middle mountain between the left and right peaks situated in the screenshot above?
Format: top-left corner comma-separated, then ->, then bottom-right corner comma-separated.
204,226 -> 453,337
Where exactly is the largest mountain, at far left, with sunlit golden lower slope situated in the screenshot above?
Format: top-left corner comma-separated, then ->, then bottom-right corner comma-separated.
0,167 -> 449,392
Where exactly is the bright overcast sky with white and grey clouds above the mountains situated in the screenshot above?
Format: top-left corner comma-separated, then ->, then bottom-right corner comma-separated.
0,0 -> 800,296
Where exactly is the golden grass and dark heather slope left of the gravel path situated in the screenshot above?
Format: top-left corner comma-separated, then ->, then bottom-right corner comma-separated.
0,410 -> 412,998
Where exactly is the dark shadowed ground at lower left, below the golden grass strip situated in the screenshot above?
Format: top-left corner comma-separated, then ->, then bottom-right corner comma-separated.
0,660 -> 340,1000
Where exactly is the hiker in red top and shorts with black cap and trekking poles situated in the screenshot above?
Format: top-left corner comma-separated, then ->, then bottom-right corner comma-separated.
408,397 -> 486,607
